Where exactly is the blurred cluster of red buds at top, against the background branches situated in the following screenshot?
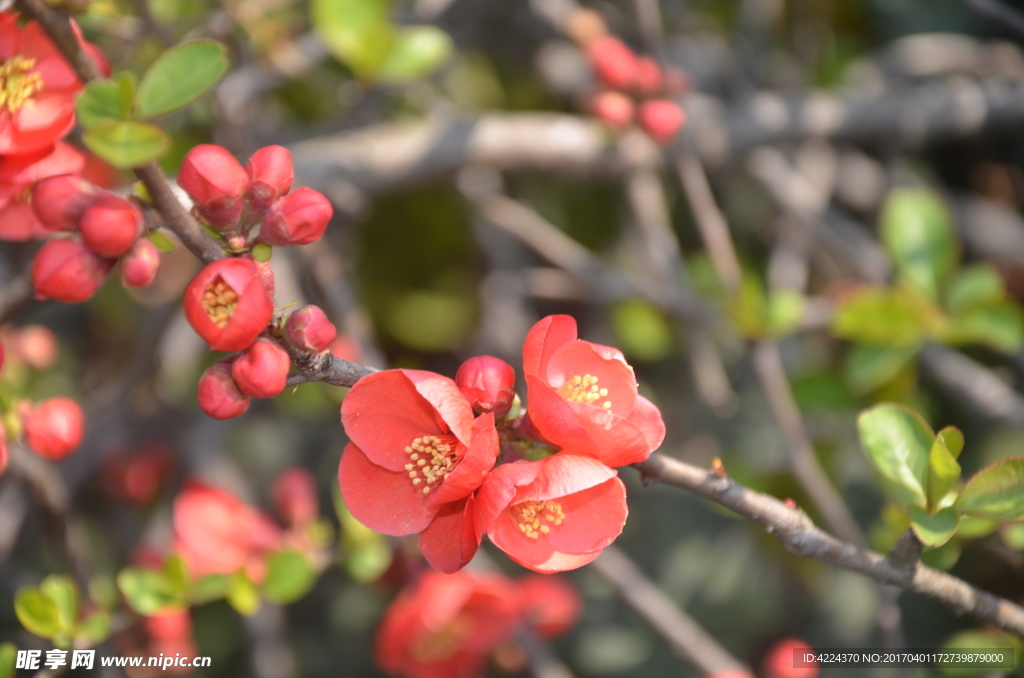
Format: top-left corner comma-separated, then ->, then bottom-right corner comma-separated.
566,9 -> 688,143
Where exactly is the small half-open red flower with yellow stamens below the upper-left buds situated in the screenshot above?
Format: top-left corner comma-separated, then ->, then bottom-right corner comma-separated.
182,257 -> 273,350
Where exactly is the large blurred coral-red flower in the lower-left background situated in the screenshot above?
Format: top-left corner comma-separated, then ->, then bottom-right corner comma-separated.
174,480 -> 283,577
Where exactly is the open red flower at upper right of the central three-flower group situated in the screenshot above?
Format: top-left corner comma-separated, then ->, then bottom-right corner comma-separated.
522,315 -> 665,466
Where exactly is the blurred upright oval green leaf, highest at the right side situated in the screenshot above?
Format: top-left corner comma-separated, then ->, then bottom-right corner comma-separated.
881,188 -> 959,301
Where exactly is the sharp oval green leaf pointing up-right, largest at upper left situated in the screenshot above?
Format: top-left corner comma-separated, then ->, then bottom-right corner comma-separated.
135,40 -> 228,120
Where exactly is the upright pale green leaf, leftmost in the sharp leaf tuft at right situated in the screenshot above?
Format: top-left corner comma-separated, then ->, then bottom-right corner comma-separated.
857,404 -> 935,507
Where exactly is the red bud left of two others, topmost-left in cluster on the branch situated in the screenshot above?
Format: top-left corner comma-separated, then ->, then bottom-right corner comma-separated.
178,143 -> 249,230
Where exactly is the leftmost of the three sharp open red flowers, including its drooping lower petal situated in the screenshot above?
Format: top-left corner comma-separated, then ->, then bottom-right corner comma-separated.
338,370 -> 499,571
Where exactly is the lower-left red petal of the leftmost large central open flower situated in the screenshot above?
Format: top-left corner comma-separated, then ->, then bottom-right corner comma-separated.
338,443 -> 437,537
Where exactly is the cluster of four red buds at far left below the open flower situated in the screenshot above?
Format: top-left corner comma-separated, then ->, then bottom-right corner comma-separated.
32,175 -> 160,303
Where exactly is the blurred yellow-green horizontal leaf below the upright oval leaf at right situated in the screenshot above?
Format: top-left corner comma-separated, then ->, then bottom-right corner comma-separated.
831,287 -> 943,347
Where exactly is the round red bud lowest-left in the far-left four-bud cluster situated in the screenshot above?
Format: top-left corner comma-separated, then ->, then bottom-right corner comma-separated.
32,239 -> 111,303
